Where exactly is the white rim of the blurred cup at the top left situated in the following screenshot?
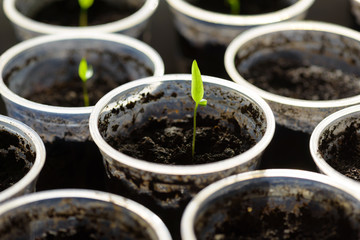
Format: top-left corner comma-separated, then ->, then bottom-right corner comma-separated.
3,0 -> 159,34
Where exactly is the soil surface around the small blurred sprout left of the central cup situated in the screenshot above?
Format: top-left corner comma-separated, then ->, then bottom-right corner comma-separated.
24,71 -> 126,107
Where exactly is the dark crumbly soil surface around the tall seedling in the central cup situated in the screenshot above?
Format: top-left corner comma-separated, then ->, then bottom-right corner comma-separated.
106,116 -> 256,165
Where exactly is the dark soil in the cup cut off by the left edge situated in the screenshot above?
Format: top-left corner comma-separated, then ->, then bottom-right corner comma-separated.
0,130 -> 36,191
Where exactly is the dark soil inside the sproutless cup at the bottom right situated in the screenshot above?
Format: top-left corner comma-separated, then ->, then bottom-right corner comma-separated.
195,193 -> 358,240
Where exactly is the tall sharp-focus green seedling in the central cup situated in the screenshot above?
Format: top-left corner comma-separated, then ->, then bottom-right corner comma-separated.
191,60 -> 207,157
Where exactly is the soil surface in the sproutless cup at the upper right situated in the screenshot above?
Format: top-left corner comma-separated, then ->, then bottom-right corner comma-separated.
237,58 -> 360,100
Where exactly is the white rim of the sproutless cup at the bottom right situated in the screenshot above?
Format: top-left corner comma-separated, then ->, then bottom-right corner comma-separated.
180,169 -> 360,240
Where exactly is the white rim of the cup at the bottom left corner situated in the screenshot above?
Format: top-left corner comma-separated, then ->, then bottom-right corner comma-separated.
0,189 -> 171,240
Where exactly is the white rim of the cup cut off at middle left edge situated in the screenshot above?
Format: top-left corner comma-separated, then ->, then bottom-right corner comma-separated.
0,115 -> 46,202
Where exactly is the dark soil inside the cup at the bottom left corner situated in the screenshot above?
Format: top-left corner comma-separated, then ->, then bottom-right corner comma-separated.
0,204 -> 150,240
